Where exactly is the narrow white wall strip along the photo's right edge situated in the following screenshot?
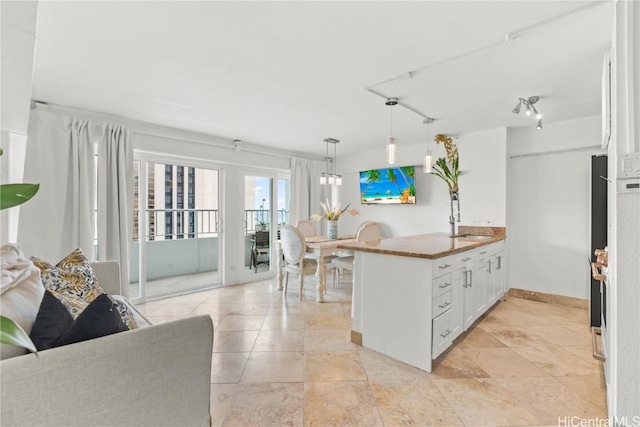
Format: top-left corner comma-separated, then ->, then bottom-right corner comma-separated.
607,1 -> 640,418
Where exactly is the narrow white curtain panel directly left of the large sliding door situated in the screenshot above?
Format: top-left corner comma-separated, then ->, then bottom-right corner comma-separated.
97,123 -> 134,297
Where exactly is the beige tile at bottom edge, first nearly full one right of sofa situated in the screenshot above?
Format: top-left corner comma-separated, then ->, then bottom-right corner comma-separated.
223,383 -> 304,426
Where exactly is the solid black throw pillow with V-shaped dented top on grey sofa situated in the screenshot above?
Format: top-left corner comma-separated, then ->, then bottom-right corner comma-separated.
30,291 -> 128,351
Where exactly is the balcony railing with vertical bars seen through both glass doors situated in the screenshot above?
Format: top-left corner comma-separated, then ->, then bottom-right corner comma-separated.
134,209 -> 289,241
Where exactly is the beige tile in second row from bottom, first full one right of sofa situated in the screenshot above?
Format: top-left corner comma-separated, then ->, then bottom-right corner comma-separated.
241,351 -> 304,383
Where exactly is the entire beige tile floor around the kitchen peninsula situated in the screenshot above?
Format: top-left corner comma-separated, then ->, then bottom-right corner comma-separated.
138,276 -> 607,426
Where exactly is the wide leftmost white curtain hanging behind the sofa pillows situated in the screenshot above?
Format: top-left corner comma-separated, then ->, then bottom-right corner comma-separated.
18,104 -> 95,263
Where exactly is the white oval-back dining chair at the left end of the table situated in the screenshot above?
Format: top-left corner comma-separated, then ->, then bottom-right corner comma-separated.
280,225 -> 331,300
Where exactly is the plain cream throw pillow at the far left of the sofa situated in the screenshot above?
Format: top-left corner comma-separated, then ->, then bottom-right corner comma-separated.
0,243 -> 44,360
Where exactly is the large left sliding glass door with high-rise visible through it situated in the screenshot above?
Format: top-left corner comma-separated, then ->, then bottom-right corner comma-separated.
130,157 -> 220,300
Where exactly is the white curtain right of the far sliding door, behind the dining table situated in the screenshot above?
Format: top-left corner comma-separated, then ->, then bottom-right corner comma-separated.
289,157 -> 328,225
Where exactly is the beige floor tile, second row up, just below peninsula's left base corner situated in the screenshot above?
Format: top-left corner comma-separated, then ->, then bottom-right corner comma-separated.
304,350 -> 367,382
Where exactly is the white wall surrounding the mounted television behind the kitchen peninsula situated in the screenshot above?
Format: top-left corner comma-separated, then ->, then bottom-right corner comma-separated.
338,128 -> 506,237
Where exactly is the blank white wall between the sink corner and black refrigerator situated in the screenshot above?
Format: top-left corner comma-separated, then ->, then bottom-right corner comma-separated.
507,116 -> 604,299
